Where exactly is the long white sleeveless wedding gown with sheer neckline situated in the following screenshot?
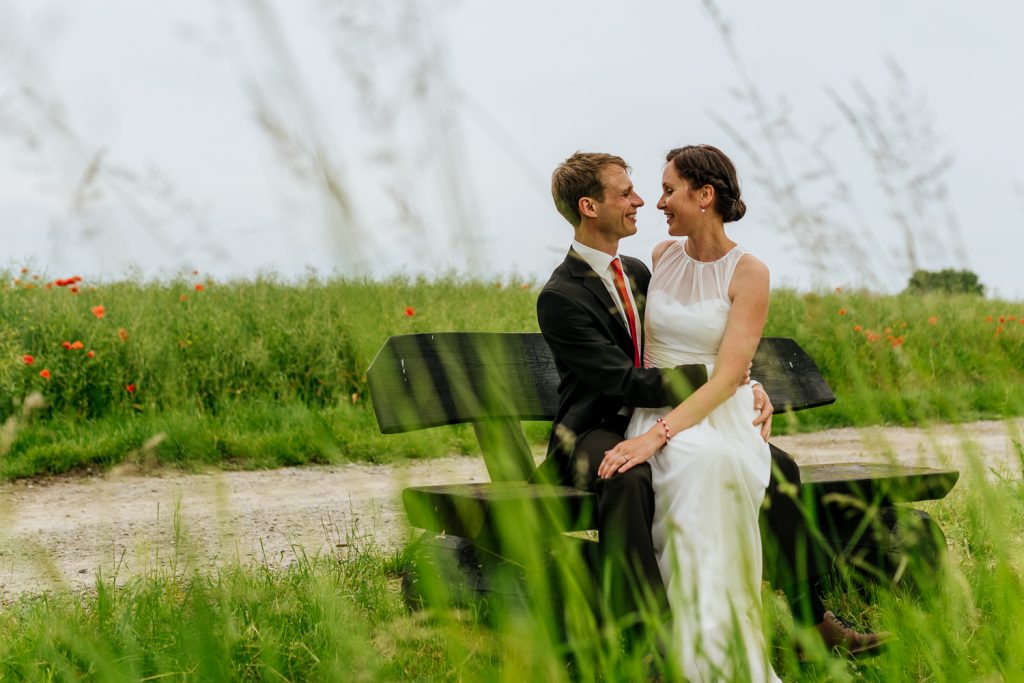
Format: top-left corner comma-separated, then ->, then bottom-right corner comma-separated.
626,242 -> 778,681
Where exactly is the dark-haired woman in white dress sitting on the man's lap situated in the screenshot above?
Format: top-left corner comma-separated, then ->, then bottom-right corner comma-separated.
598,145 -> 778,681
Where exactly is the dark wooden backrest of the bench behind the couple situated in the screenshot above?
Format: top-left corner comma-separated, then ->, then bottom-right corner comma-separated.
367,332 -> 836,481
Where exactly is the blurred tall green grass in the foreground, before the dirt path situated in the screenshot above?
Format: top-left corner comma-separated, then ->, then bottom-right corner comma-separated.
0,452 -> 1024,682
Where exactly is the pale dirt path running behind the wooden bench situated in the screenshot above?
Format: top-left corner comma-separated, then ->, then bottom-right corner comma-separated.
0,420 -> 1024,600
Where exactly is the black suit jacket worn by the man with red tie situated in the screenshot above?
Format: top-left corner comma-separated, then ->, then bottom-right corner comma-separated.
537,249 -> 708,483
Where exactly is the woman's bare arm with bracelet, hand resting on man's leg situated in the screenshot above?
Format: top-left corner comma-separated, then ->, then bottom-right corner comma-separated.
598,254 -> 769,477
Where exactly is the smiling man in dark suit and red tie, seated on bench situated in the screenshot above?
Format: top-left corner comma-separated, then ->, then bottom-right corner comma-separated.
532,153 -> 874,651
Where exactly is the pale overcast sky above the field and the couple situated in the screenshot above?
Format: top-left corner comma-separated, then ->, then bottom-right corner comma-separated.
0,0 -> 1024,299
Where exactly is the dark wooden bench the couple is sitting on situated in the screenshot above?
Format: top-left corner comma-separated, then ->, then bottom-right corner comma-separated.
367,333 -> 958,606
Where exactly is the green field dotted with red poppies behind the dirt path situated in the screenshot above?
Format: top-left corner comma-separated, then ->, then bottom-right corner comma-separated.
0,272 -> 1024,478
